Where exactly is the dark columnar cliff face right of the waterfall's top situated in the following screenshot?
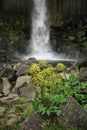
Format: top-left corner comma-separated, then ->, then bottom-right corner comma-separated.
48,0 -> 87,25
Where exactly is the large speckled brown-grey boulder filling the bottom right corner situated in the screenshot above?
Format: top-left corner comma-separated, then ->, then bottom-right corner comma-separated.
59,96 -> 87,130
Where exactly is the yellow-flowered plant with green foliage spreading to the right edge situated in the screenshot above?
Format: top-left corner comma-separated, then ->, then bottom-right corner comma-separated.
28,63 -> 87,116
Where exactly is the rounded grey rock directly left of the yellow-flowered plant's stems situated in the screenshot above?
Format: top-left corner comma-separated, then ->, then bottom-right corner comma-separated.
19,83 -> 36,101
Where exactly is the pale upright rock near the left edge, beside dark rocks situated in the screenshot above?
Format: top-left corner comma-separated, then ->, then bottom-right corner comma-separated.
2,78 -> 12,95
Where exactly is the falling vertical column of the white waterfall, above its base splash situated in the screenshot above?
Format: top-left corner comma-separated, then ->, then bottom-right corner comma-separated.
31,0 -> 51,55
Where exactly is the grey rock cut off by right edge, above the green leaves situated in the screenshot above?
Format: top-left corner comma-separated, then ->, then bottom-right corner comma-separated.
79,67 -> 87,81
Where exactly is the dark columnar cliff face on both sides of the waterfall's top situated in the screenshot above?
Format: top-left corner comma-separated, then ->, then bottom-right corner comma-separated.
0,0 -> 87,26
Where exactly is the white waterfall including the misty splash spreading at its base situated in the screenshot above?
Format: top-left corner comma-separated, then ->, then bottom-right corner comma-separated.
22,0 -> 75,60
